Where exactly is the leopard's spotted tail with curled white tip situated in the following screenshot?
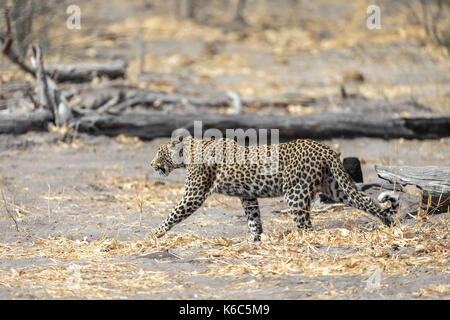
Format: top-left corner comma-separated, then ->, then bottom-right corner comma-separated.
327,150 -> 399,226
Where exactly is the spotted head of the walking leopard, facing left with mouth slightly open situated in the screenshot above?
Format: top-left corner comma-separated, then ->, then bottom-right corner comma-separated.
151,136 -> 184,177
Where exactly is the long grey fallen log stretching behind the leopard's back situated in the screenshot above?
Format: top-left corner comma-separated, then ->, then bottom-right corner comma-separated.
74,112 -> 450,140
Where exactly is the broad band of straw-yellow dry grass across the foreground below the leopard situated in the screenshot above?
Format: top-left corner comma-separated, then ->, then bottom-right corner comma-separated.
0,220 -> 450,298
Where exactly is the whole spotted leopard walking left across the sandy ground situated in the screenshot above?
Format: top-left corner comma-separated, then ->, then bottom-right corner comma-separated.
151,136 -> 399,241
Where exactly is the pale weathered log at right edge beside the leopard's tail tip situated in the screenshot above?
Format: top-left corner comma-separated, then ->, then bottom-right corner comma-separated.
375,165 -> 450,212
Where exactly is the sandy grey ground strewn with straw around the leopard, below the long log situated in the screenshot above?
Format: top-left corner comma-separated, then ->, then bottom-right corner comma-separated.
0,133 -> 450,299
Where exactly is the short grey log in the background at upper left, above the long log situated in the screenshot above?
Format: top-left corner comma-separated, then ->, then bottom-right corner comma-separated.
46,60 -> 127,82
